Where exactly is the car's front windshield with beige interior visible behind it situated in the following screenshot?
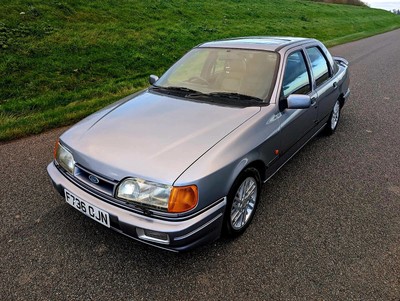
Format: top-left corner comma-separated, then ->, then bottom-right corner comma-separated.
155,48 -> 278,101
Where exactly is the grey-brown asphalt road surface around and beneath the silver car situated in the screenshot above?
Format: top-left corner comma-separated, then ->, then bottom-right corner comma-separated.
0,30 -> 400,300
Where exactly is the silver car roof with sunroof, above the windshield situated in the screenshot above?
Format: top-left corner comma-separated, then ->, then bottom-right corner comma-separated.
197,36 -> 315,51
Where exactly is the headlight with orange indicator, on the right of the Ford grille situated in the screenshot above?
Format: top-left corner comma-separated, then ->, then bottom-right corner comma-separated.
117,178 -> 198,213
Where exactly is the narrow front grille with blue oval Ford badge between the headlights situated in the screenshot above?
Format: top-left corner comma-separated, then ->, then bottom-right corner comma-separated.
74,164 -> 118,197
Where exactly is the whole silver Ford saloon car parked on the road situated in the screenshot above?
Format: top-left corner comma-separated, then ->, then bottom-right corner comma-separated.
47,37 -> 350,251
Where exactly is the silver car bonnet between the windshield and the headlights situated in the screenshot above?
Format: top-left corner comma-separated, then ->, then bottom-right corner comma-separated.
61,92 -> 260,184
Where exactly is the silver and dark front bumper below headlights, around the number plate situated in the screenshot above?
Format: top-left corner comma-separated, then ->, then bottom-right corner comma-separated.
47,162 -> 226,251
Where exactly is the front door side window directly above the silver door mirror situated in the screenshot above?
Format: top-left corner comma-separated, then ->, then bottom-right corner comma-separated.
282,51 -> 311,98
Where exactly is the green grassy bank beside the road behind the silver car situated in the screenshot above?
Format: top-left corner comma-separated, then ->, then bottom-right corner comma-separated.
0,0 -> 400,141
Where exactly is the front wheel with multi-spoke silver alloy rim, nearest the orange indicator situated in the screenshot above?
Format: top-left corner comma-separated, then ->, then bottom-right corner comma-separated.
224,167 -> 261,238
